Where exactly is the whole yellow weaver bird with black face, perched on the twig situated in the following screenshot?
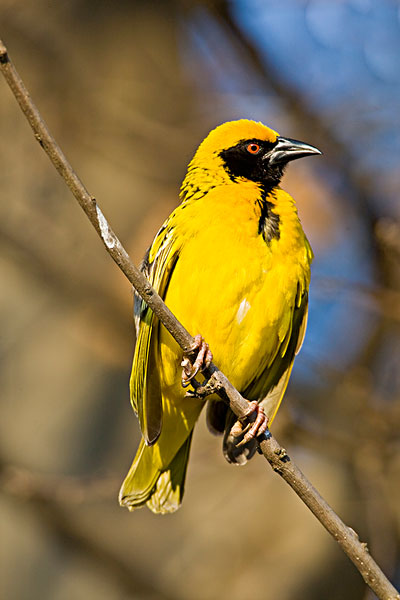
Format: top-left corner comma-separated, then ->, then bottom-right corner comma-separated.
119,120 -> 321,513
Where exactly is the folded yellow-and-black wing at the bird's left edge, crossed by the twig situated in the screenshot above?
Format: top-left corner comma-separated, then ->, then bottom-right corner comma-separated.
130,219 -> 179,445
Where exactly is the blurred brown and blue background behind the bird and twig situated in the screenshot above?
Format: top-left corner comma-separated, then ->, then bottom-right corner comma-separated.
0,0 -> 400,600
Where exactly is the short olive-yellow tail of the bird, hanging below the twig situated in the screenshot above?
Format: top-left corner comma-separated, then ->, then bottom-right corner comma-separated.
119,433 -> 192,514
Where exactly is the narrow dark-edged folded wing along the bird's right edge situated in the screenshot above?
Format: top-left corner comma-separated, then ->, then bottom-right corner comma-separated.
244,287 -> 308,423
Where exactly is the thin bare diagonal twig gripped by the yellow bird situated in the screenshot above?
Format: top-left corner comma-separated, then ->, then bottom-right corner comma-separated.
0,40 -> 400,600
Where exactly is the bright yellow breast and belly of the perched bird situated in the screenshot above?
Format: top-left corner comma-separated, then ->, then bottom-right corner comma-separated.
160,181 -> 312,395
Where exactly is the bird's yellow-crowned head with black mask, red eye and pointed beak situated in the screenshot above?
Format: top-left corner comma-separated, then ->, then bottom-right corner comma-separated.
183,119 -> 322,200
